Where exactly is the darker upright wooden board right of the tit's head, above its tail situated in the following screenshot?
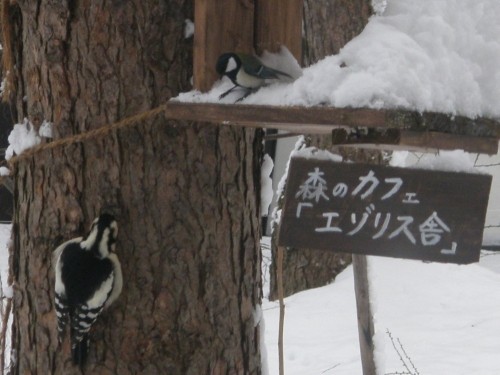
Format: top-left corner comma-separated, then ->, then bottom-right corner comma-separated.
255,0 -> 303,62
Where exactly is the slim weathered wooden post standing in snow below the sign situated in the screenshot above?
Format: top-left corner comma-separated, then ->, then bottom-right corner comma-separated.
352,254 -> 376,375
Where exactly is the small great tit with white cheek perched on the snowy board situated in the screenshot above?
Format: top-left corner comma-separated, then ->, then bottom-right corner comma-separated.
215,53 -> 292,101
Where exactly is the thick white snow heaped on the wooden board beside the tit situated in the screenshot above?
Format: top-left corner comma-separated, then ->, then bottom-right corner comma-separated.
178,0 -> 500,117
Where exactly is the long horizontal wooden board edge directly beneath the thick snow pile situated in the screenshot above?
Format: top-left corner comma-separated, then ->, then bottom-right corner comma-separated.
165,101 -> 500,139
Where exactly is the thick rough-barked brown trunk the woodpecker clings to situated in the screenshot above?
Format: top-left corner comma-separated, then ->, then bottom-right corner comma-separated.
6,0 -> 261,375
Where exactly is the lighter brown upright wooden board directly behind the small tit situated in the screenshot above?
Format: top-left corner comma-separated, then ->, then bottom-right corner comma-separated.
193,0 -> 254,91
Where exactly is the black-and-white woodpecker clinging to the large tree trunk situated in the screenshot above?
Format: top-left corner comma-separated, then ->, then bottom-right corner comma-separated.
54,214 -> 123,367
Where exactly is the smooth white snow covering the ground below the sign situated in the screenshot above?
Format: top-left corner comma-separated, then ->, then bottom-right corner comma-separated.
262,239 -> 500,375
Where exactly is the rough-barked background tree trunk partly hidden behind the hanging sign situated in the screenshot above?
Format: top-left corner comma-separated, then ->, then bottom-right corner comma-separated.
269,0 -> 379,299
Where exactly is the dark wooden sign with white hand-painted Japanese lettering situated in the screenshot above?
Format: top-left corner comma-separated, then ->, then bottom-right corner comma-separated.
279,158 -> 491,264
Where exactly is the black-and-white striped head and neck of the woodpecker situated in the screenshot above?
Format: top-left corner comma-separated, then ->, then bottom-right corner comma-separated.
81,213 -> 118,258
